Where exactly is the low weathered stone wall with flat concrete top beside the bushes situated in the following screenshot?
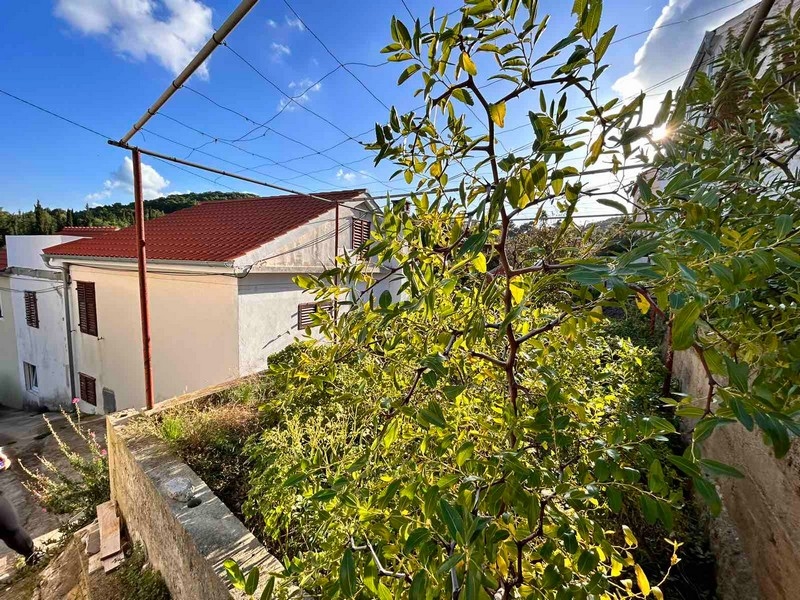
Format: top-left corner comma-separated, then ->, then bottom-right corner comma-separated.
107,411 -> 281,600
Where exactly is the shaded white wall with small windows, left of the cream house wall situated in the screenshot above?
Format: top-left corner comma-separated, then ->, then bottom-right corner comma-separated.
10,275 -> 72,409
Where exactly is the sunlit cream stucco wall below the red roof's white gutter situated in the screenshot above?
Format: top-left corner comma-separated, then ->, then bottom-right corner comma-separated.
70,265 -> 239,412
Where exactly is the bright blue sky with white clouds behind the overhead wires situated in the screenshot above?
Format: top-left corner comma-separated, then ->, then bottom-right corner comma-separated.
0,0 -> 756,216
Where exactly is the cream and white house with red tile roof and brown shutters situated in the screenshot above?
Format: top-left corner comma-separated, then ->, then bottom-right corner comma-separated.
40,190 -> 394,412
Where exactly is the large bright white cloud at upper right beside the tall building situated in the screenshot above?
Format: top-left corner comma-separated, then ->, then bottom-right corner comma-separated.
612,0 -> 757,116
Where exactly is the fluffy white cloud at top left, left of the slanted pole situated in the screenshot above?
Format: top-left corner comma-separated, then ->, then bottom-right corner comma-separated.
55,0 -> 214,79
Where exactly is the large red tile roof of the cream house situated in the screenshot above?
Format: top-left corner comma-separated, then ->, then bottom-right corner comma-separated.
44,189 -> 365,262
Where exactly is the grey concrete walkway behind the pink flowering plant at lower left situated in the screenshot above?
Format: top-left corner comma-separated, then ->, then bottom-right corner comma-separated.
0,406 -> 105,582
